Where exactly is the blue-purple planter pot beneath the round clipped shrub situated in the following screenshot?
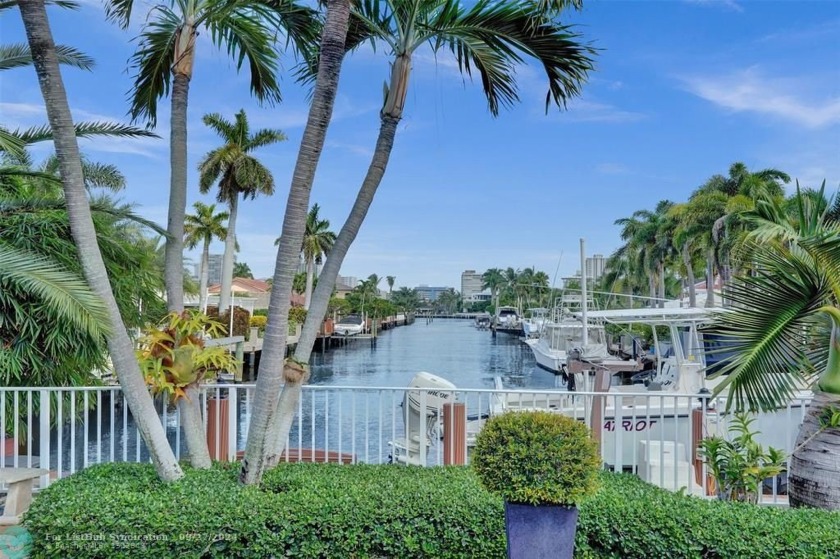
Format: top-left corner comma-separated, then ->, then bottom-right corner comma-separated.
505,502 -> 578,559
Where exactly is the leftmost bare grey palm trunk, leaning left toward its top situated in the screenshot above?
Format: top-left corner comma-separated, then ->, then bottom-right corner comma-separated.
19,0 -> 184,481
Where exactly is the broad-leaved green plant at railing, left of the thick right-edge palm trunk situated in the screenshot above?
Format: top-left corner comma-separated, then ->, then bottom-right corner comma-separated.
700,413 -> 785,504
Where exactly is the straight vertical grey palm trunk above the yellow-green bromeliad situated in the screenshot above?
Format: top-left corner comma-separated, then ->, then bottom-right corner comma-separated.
163,23 -> 195,312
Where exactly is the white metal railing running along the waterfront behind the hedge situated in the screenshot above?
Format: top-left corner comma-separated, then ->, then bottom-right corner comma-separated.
0,384 -> 810,502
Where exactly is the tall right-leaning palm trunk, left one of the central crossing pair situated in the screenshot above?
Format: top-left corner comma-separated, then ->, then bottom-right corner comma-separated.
239,0 -> 350,484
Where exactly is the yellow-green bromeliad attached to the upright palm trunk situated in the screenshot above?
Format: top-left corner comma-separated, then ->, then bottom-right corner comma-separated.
137,311 -> 237,403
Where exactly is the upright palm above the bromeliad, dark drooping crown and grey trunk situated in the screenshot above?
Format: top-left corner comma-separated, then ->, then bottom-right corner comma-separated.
106,0 -> 318,312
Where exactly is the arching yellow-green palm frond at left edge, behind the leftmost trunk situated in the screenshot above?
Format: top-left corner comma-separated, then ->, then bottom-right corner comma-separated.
0,243 -> 110,338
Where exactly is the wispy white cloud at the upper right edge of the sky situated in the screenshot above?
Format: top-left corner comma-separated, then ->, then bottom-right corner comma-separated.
682,67 -> 840,128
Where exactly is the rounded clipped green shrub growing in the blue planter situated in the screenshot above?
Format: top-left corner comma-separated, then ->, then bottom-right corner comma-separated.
470,411 -> 601,505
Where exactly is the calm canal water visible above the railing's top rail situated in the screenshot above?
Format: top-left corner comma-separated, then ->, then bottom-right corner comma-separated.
310,319 -> 554,388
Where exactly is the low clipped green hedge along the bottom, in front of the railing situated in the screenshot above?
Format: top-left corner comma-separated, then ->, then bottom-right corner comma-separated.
24,464 -> 840,559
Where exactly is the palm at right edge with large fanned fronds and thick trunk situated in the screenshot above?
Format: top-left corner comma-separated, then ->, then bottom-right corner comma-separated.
711,186 -> 840,509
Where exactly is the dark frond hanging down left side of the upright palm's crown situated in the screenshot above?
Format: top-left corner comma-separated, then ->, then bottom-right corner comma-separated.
129,6 -> 181,126
